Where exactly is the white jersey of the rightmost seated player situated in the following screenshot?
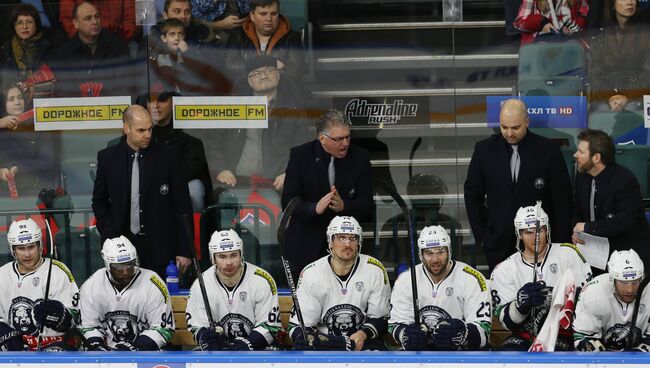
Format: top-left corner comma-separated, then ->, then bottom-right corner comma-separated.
573,274 -> 650,350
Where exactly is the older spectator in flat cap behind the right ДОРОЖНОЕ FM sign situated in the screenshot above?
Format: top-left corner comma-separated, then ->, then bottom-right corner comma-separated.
209,55 -> 309,191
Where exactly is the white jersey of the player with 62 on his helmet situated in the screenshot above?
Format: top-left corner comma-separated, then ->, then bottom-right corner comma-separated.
185,262 -> 282,344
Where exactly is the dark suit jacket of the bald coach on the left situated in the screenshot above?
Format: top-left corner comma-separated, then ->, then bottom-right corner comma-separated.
92,137 -> 192,265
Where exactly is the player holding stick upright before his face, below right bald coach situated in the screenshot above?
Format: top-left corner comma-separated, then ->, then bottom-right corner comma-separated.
491,206 -> 591,351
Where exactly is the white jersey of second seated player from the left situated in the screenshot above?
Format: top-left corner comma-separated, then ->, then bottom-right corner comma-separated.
79,268 -> 174,348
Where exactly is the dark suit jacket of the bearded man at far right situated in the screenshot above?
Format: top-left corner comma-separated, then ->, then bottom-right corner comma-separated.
573,163 -> 650,264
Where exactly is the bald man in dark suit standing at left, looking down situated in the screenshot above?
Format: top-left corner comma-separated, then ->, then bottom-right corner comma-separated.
92,105 -> 192,277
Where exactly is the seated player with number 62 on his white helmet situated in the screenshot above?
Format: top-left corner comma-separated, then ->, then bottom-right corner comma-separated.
185,230 -> 282,350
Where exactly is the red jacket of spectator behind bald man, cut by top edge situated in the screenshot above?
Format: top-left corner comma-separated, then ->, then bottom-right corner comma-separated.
59,0 -> 139,43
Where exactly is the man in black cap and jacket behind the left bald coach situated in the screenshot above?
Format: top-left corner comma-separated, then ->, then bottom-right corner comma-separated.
139,92 -> 212,213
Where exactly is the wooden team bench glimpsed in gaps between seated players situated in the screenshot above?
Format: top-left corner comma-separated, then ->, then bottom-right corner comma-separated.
167,295 -> 510,349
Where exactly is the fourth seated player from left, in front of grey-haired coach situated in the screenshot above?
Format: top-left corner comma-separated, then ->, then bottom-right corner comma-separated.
290,216 -> 390,350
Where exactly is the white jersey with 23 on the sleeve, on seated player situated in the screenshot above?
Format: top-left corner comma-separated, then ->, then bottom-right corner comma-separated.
388,261 -> 492,347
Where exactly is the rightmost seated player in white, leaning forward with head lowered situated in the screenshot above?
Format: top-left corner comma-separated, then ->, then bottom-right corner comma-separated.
573,249 -> 650,352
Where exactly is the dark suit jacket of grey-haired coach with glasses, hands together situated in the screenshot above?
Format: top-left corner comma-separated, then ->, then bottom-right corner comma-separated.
282,140 -> 373,272
